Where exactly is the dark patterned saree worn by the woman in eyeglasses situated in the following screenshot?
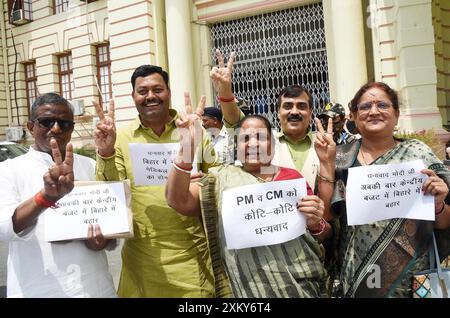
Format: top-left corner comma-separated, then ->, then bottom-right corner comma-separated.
331,139 -> 450,298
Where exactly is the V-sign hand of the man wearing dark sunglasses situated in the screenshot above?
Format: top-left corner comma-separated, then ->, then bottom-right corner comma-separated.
43,138 -> 74,201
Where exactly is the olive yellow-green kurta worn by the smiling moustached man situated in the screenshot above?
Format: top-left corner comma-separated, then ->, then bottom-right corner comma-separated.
96,109 -> 215,297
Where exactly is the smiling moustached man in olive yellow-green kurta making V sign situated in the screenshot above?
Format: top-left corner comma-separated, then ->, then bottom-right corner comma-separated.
94,65 -> 216,297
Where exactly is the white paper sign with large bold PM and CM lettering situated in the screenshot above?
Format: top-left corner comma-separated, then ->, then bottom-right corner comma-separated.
222,179 -> 306,249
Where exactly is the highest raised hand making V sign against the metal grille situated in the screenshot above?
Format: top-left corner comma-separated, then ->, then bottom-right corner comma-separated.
210,49 -> 236,98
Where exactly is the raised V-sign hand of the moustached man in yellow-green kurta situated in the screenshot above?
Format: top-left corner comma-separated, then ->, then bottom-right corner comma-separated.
93,100 -> 116,157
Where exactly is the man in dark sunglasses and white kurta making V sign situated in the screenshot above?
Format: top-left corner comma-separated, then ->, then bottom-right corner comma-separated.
0,93 -> 116,298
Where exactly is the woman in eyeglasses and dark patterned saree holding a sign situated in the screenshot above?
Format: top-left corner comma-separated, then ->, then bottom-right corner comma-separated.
326,82 -> 450,297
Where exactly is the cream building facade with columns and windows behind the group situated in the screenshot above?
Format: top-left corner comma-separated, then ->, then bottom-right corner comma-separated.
0,0 -> 450,146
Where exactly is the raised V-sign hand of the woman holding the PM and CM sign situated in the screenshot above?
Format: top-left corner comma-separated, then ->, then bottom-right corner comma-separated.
175,92 -> 206,164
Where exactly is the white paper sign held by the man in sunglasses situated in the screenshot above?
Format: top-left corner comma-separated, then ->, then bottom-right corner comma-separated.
43,180 -> 133,242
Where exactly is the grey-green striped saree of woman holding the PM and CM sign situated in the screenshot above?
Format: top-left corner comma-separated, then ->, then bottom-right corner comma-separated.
200,165 -> 327,298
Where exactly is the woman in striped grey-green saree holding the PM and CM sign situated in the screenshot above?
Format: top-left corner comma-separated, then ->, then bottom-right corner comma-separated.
166,108 -> 331,298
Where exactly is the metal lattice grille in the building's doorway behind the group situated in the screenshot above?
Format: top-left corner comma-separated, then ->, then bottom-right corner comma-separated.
211,3 -> 329,128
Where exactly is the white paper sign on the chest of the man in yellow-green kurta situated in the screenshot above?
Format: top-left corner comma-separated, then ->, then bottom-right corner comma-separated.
129,143 -> 196,186
